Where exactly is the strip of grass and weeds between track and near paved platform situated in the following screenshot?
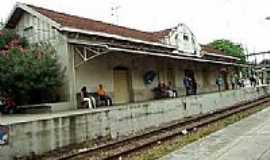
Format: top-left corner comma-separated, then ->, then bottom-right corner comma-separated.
131,105 -> 266,160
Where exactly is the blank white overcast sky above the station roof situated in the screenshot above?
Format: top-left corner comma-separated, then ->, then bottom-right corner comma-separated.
0,0 -> 270,60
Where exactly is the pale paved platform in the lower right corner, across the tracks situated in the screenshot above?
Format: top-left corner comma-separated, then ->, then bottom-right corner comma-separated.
160,105 -> 270,160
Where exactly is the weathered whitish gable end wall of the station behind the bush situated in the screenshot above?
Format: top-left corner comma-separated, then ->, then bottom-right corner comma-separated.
16,12 -> 74,103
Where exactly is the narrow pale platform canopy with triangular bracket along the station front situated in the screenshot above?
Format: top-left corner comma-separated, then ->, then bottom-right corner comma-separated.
69,40 -> 249,67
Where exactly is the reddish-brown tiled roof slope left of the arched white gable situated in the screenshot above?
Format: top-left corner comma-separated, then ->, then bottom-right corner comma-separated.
27,5 -> 170,43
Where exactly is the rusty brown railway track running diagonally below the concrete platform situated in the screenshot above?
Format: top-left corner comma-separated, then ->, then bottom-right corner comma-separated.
43,97 -> 270,160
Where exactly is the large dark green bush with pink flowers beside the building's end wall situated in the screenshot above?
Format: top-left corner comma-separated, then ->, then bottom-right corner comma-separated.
0,31 -> 64,104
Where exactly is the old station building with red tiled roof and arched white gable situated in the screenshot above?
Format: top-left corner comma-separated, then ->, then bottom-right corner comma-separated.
6,3 -> 244,109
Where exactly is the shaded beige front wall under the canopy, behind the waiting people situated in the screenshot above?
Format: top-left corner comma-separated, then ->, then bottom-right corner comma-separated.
71,47 -> 228,101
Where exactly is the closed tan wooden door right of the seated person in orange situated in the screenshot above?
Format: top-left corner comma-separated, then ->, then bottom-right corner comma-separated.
114,69 -> 130,104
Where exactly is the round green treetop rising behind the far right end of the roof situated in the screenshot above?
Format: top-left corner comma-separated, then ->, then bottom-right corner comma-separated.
208,39 -> 246,63
